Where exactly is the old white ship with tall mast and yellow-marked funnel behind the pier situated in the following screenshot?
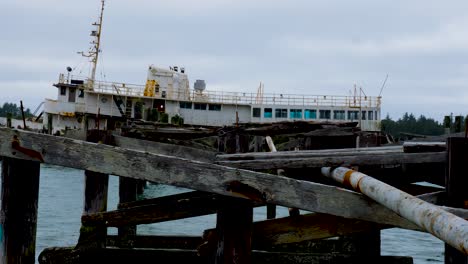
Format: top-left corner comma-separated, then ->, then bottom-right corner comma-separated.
43,1 -> 381,137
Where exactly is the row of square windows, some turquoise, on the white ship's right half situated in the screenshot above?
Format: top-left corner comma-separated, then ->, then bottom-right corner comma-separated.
252,107 -> 377,120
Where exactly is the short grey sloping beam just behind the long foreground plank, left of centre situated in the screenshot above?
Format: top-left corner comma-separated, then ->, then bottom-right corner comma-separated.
114,135 -> 215,163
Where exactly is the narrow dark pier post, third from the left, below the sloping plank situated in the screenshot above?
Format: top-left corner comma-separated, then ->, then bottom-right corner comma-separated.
118,177 -> 138,248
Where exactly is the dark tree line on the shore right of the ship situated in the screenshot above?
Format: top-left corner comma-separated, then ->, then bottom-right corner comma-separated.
381,113 -> 468,140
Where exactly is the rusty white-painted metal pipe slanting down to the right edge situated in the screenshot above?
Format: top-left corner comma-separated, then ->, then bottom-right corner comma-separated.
322,167 -> 468,255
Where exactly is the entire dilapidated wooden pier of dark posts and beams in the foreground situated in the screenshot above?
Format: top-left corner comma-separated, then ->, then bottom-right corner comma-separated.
0,127 -> 468,264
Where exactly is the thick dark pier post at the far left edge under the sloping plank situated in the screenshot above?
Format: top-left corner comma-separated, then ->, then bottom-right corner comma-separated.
0,157 -> 40,264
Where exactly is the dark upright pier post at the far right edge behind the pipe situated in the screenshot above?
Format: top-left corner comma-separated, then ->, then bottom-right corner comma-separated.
445,137 -> 468,264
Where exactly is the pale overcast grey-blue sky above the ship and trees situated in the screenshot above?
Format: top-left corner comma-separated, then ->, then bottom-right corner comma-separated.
0,0 -> 468,121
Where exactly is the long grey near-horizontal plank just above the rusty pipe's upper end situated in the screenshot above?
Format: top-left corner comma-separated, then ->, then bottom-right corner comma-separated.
216,152 -> 447,170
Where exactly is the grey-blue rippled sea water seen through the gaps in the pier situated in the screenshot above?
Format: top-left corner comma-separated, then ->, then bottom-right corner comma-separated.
0,161 -> 444,264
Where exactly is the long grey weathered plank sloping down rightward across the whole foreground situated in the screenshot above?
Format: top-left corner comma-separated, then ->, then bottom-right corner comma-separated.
0,128 -> 422,228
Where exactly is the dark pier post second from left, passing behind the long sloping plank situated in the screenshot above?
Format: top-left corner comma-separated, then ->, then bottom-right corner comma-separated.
77,130 -> 109,248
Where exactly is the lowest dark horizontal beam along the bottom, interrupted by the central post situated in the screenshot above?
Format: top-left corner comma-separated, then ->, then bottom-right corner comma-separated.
39,248 -> 413,264
